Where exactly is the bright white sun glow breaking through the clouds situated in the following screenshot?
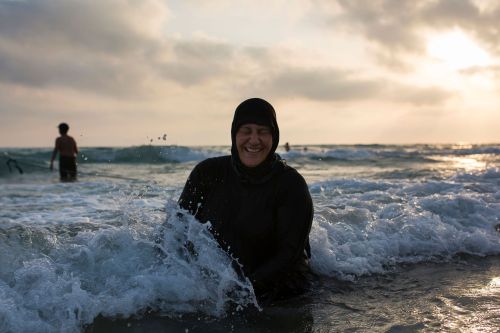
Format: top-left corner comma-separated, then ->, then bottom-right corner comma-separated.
427,30 -> 491,70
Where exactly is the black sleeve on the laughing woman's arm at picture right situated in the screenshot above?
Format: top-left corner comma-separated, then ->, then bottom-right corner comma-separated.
250,171 -> 313,288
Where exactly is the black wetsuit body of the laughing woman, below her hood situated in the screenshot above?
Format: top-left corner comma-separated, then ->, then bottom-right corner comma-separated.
179,155 -> 313,298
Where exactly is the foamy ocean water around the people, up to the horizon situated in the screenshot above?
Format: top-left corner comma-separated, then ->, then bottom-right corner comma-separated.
0,144 -> 500,333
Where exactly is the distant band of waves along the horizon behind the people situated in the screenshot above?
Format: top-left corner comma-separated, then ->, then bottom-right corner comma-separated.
0,144 -> 500,167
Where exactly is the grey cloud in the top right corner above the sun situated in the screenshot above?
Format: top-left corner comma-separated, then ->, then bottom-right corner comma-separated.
325,0 -> 500,60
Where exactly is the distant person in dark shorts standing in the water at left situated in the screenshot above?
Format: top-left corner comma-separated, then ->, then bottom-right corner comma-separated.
50,123 -> 78,181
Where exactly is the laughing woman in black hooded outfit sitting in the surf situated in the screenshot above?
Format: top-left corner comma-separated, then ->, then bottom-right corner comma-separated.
179,98 -> 313,300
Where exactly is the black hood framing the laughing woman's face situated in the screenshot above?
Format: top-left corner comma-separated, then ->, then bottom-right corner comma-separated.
231,98 -> 284,184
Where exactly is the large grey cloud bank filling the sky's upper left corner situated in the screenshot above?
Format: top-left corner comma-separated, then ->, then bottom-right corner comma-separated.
0,0 -> 168,95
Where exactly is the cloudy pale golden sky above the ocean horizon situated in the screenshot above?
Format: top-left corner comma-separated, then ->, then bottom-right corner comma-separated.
0,0 -> 500,147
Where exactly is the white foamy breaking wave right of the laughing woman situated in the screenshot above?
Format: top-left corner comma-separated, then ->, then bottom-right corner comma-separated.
311,170 -> 500,280
